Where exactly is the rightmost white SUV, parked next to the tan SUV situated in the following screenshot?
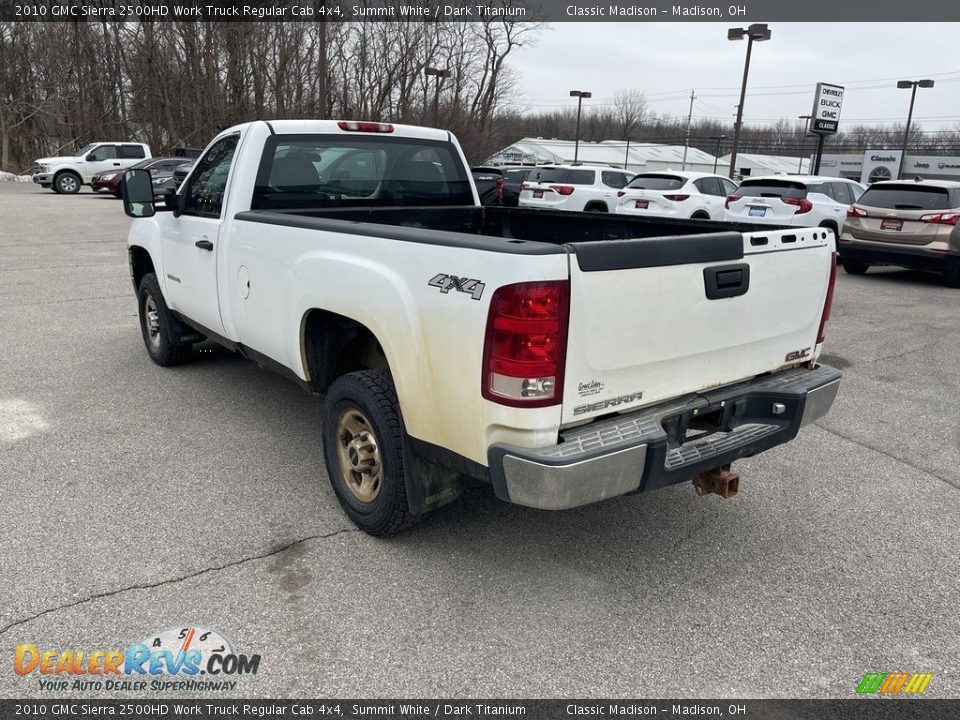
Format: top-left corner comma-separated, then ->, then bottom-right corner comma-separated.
726,175 -> 866,235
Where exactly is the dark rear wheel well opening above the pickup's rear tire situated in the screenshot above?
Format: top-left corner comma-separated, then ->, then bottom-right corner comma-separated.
300,309 -> 390,394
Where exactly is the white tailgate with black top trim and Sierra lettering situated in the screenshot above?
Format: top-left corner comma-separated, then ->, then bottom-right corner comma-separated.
561,228 -> 834,425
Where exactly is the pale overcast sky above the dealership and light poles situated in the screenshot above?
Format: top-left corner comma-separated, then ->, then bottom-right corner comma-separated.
511,22 -> 960,130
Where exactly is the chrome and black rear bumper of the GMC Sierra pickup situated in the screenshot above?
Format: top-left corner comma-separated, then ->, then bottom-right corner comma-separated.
488,365 -> 841,510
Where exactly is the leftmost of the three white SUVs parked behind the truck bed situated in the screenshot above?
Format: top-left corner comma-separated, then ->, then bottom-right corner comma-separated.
520,165 -> 635,212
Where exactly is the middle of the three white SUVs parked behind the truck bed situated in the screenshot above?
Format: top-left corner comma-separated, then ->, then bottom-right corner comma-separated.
617,171 -> 737,220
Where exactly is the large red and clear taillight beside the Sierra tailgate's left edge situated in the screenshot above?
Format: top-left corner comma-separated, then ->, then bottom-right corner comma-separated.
481,280 -> 570,407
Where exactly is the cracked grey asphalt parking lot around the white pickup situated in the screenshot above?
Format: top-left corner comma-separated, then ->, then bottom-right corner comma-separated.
0,184 -> 960,698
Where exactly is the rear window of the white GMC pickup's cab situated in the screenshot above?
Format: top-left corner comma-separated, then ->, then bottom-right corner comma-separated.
251,134 -> 474,210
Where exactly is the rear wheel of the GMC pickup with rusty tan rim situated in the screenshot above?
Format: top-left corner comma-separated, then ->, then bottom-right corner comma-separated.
323,370 -> 420,537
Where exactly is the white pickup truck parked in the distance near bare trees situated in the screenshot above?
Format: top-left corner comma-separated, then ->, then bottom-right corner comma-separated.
33,142 -> 153,195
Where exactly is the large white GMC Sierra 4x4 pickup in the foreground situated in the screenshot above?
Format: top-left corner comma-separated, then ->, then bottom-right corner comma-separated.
124,120 -> 840,535
